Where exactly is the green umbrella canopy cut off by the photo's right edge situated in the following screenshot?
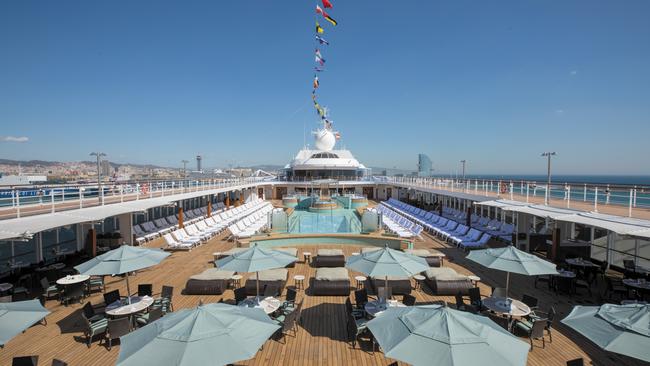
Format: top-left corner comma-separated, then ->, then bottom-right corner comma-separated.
562,304 -> 650,362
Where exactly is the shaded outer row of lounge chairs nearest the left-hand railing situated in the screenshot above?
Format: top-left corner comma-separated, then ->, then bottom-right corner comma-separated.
132,202 -> 226,245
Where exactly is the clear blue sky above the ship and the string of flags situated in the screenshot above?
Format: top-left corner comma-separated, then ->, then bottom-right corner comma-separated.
0,0 -> 650,174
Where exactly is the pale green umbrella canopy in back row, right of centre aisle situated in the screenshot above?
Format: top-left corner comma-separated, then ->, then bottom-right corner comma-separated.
345,247 -> 429,277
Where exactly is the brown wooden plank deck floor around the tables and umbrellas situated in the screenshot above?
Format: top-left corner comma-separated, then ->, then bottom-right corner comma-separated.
0,233 -> 640,366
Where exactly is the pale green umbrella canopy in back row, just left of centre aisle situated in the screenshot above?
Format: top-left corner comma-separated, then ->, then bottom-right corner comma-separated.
217,245 -> 298,272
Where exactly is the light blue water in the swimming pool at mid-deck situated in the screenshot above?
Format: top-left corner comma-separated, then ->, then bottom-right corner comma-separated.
289,209 -> 361,234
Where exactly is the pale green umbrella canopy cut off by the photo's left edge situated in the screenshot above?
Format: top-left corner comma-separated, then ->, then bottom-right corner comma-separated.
0,299 -> 50,346
